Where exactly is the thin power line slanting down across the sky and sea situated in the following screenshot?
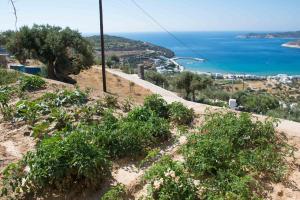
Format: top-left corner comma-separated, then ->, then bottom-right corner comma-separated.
131,0 -> 201,58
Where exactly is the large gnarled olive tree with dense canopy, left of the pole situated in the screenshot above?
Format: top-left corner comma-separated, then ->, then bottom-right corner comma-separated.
6,25 -> 94,83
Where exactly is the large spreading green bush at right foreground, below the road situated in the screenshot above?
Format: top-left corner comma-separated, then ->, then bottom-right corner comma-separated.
184,113 -> 289,199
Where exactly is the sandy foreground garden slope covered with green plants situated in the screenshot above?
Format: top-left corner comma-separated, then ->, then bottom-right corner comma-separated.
0,67 -> 300,200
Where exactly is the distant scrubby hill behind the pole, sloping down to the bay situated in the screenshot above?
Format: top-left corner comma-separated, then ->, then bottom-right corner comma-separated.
86,35 -> 175,58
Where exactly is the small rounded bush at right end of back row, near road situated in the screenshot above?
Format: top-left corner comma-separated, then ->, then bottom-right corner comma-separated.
169,102 -> 195,125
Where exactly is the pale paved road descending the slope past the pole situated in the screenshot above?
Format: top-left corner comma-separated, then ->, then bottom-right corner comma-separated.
107,69 -> 300,137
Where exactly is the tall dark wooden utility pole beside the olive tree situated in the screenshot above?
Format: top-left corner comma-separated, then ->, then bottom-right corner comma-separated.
99,0 -> 107,92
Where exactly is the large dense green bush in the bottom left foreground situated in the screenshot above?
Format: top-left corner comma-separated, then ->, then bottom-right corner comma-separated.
3,131 -> 111,198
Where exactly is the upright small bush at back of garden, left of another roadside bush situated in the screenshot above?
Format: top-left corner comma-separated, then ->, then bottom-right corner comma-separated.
144,94 -> 169,118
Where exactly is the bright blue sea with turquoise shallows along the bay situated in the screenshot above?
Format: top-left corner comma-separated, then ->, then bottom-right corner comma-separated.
115,32 -> 300,75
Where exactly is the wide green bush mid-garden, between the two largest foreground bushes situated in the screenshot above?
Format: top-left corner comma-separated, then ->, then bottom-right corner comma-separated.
90,108 -> 170,158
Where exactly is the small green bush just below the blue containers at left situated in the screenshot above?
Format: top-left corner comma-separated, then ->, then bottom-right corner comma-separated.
20,76 -> 46,91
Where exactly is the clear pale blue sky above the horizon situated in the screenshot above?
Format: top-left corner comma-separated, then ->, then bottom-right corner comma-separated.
0,0 -> 300,33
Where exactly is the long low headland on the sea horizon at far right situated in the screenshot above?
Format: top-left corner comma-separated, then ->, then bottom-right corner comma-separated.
238,31 -> 300,39
